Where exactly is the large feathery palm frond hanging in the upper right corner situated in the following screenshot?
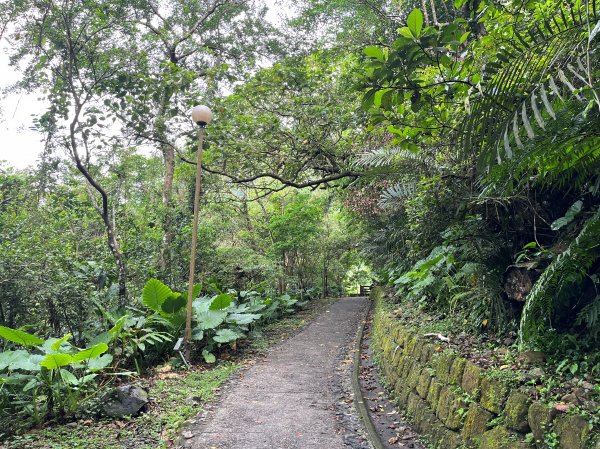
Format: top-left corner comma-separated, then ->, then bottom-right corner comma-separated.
460,5 -> 600,182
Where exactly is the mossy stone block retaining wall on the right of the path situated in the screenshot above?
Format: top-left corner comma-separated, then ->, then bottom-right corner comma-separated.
371,289 -> 600,449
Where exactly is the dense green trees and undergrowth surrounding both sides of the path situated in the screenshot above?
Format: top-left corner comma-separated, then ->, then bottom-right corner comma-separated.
0,0 -> 600,440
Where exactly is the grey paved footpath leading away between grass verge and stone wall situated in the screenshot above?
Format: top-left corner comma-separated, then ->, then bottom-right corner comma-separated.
182,298 -> 368,449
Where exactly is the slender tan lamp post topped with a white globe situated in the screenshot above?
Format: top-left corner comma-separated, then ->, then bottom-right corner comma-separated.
184,106 -> 213,360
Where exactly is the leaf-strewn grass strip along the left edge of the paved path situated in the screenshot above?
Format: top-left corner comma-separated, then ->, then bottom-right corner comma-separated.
0,298 -> 336,449
